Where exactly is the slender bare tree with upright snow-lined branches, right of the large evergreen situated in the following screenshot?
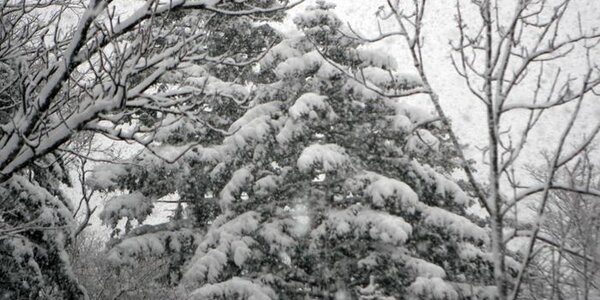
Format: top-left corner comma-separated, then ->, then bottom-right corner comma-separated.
336,0 -> 600,300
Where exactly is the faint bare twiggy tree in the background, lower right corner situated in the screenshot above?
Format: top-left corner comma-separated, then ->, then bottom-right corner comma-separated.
525,151 -> 600,299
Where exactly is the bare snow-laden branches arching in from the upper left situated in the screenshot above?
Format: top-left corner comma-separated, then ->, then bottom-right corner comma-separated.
0,0 -> 298,181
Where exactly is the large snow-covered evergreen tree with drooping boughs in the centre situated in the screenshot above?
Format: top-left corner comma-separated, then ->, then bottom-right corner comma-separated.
97,2 -> 511,299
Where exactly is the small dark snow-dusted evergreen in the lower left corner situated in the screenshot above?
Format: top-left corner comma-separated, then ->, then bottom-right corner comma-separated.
0,154 -> 84,299
